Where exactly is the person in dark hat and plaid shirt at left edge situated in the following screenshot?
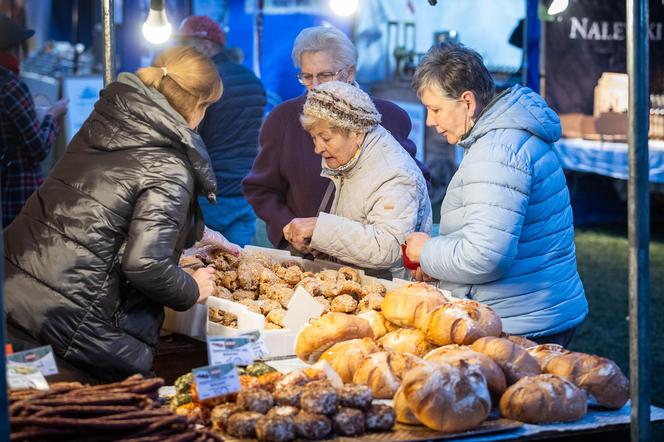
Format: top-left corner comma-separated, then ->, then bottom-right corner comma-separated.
0,14 -> 69,227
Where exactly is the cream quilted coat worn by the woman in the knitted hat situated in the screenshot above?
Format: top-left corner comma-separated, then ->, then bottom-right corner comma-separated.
311,126 -> 431,269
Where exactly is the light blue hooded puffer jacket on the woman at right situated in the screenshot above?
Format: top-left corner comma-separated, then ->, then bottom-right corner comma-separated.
420,86 -> 588,337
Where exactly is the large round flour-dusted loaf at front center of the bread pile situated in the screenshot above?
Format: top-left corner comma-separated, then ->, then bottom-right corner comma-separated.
401,361 -> 491,433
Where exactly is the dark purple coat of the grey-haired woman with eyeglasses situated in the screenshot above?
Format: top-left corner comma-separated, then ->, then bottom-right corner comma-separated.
242,94 -> 430,247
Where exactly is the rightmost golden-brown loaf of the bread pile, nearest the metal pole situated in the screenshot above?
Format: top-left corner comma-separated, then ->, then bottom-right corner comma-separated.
546,352 -> 629,409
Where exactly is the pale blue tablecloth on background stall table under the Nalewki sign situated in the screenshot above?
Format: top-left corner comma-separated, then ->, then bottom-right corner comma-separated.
555,138 -> 664,183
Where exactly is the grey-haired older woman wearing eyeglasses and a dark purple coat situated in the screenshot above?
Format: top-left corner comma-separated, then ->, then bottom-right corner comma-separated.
242,26 -> 428,248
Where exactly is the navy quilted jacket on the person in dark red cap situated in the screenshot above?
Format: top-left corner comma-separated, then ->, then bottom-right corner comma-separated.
198,52 -> 265,197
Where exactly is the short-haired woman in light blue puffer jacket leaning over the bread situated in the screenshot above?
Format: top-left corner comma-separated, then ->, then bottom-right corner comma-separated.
406,45 -> 588,346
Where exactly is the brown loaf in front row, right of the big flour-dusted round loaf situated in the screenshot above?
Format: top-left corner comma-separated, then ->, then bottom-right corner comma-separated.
500,374 -> 588,424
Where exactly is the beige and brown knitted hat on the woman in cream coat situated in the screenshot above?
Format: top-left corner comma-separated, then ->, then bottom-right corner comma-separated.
302,81 -> 381,132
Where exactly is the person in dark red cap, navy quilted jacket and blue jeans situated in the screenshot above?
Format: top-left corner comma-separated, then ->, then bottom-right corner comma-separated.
178,15 -> 266,246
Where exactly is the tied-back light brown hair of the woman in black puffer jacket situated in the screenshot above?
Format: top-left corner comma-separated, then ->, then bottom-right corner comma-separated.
136,46 -> 223,121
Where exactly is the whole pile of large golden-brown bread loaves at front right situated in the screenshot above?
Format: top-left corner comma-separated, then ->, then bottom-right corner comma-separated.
296,283 -> 629,432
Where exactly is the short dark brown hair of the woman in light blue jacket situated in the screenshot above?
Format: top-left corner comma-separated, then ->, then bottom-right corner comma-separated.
413,43 -> 496,107
